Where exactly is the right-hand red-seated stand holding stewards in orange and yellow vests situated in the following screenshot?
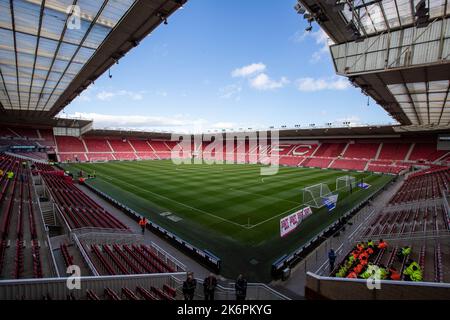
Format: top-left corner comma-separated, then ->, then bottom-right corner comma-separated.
322,161 -> 450,292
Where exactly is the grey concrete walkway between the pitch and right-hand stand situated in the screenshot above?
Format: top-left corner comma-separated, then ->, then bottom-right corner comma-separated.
271,178 -> 403,297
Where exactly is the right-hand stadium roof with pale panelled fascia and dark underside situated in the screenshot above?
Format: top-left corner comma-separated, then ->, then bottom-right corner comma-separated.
299,0 -> 450,127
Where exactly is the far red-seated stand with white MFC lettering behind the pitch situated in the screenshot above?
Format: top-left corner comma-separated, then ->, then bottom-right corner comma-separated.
51,136 -> 446,178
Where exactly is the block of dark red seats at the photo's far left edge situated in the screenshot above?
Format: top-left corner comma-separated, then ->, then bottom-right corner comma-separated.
0,154 -> 51,279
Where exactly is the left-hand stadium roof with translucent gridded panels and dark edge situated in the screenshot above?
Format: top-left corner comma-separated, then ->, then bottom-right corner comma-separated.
0,0 -> 186,118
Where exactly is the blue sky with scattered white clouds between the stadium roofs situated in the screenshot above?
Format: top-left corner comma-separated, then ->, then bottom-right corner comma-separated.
65,0 -> 392,131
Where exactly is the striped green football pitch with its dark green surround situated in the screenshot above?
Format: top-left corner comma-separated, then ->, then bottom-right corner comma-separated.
60,160 -> 392,281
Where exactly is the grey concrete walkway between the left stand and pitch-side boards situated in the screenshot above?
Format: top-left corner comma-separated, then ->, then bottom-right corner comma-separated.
76,184 -> 210,279
